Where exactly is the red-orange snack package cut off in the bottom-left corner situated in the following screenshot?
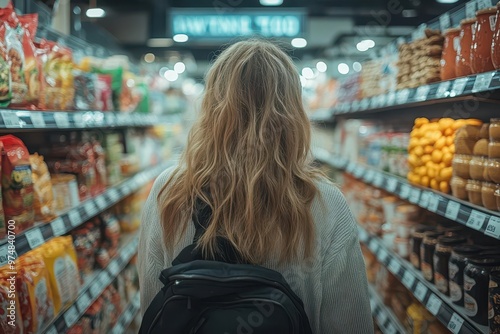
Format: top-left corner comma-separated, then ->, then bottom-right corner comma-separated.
0,266 -> 23,334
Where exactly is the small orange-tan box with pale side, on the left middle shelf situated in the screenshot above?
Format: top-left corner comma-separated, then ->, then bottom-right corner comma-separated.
51,174 -> 80,214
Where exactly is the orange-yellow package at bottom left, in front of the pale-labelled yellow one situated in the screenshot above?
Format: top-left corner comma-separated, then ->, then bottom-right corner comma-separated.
17,252 -> 55,334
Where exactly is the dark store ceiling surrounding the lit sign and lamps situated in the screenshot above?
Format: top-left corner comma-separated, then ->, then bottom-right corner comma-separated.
72,0 -> 465,71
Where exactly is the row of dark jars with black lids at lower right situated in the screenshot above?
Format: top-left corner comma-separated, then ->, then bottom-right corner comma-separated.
410,226 -> 500,333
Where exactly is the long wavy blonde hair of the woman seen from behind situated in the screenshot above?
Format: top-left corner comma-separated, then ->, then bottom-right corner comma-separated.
158,40 -> 320,264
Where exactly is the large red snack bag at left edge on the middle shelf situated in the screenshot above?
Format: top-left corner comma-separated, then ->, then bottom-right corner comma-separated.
0,135 -> 35,233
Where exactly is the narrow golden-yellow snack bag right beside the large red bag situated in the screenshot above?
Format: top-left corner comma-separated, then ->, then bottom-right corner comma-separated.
30,153 -> 56,221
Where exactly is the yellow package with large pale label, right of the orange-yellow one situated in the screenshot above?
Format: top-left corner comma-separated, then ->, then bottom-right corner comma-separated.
40,237 -> 79,314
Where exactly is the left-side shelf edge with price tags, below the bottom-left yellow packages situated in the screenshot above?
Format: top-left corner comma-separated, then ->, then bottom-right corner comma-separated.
42,234 -> 139,334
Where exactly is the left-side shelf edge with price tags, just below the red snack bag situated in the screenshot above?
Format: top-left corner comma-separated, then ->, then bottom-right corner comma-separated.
0,161 -> 174,267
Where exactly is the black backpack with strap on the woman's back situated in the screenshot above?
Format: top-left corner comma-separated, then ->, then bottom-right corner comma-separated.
139,200 -> 312,334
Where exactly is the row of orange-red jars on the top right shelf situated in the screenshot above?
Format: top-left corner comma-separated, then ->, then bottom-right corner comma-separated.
441,2 -> 500,80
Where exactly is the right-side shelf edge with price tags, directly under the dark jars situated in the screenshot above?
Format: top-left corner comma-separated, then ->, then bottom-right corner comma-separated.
358,227 -> 489,334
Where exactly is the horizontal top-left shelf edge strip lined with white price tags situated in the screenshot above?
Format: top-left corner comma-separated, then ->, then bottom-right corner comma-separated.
0,109 -> 180,130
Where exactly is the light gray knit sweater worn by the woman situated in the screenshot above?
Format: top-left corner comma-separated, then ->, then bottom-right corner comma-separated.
138,169 -> 374,334
